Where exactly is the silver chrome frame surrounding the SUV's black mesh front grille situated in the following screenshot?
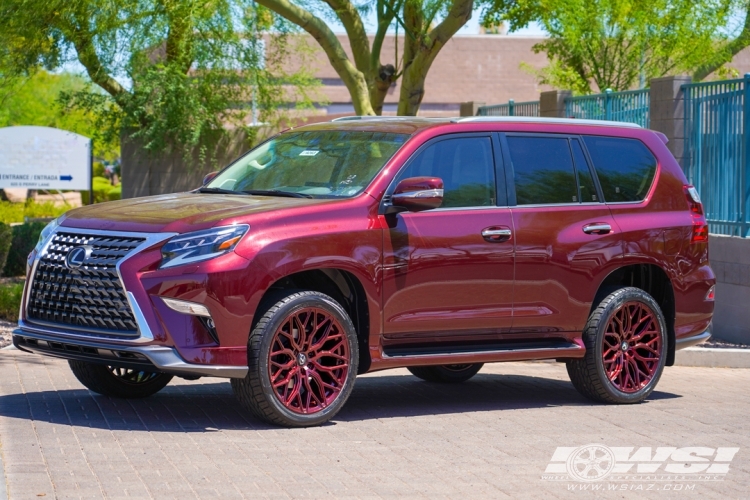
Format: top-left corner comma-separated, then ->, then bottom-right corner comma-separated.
23,226 -> 179,344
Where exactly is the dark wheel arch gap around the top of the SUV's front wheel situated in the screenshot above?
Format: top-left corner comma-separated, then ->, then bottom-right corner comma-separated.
253,268 -> 371,373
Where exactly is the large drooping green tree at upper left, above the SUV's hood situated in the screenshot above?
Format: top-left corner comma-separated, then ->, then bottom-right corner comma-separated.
0,0 -> 312,156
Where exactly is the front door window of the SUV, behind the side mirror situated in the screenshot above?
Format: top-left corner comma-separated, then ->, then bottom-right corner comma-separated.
398,137 -> 495,208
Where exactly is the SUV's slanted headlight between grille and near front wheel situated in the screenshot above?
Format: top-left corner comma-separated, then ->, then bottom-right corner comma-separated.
159,224 -> 250,269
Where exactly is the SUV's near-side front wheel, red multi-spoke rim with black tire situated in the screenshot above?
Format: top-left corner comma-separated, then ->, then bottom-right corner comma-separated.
232,291 -> 359,427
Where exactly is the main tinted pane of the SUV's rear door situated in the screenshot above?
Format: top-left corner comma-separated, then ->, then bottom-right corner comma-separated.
507,137 -> 578,205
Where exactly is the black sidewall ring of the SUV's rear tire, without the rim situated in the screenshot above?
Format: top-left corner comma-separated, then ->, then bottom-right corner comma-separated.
594,288 -> 667,403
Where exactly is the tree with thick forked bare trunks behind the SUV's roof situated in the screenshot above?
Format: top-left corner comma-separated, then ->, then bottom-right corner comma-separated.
258,0 -> 474,115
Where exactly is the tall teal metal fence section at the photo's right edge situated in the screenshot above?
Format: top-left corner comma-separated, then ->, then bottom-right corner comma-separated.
682,75 -> 750,237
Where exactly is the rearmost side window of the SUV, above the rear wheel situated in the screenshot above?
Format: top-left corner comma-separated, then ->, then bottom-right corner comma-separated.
583,136 -> 656,202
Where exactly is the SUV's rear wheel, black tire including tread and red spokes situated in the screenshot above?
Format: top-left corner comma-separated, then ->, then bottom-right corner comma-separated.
566,287 -> 667,404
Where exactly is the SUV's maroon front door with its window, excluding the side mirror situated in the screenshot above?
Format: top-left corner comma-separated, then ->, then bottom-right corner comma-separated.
383,134 -> 513,347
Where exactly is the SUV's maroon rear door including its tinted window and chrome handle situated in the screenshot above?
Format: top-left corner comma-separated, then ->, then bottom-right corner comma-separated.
501,133 -> 622,335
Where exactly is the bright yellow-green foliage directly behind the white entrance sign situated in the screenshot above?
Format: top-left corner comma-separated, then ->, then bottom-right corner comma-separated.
0,70 -> 120,160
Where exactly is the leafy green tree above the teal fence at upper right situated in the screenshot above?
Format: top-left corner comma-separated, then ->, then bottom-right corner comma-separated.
483,0 -> 733,93
